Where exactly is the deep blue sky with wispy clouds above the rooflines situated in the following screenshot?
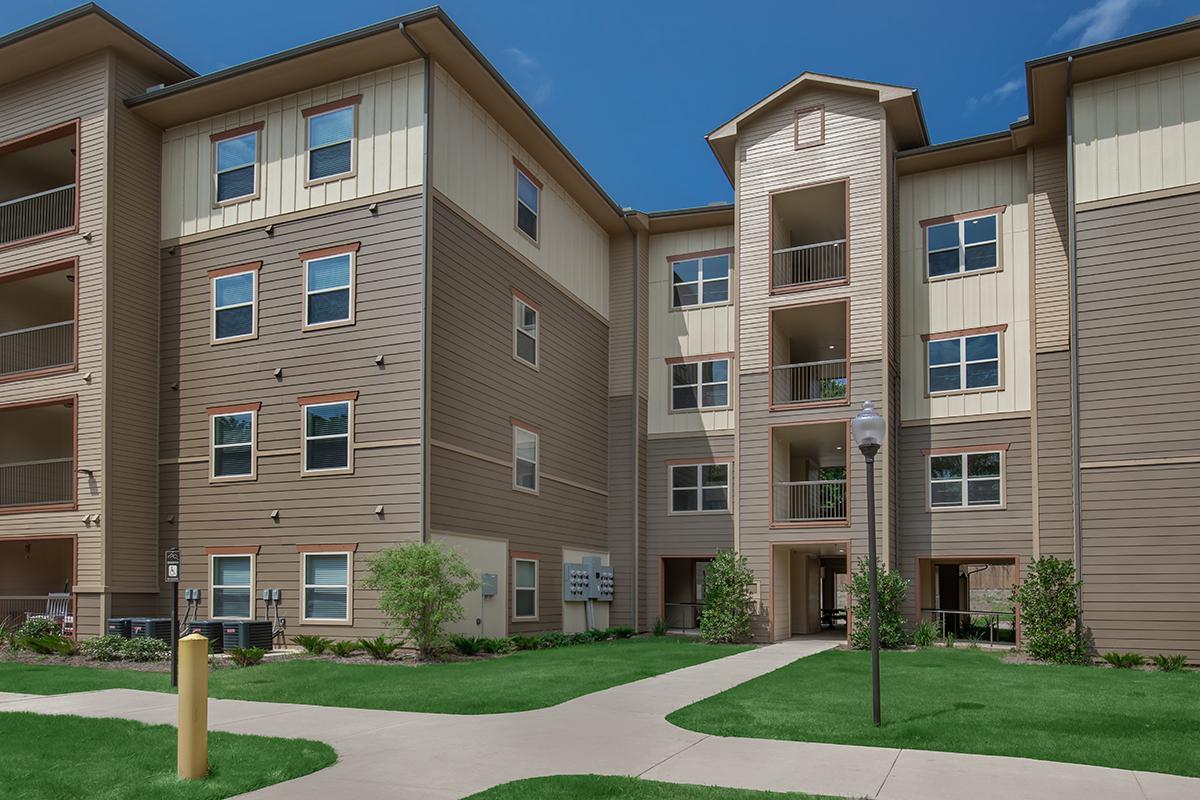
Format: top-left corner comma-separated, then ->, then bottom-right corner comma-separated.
0,0 -> 1200,210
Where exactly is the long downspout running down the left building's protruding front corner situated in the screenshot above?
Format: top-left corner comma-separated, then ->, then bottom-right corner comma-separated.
400,23 -> 433,542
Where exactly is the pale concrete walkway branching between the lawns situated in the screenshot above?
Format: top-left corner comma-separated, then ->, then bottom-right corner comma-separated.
0,639 -> 1200,800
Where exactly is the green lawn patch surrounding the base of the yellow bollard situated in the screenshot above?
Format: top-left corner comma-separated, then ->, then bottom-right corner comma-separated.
0,711 -> 337,800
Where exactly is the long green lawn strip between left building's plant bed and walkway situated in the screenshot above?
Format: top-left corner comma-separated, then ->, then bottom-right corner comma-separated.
0,637 -> 746,714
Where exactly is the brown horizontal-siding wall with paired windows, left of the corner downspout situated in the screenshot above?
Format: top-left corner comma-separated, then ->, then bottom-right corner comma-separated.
158,198 -> 421,637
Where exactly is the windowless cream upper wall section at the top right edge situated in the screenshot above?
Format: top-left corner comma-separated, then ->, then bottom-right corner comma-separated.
1073,58 -> 1200,203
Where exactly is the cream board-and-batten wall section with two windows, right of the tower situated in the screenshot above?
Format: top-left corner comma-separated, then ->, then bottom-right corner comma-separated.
899,156 -> 1032,420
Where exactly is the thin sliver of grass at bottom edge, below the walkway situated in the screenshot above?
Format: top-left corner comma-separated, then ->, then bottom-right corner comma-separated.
467,775 -> 833,800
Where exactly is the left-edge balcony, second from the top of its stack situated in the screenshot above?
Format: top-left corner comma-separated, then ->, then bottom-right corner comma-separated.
0,263 -> 76,380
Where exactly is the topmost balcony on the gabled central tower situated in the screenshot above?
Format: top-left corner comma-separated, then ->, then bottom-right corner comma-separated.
770,181 -> 850,291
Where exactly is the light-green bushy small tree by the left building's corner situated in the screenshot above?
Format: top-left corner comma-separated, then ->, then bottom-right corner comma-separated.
362,542 -> 479,658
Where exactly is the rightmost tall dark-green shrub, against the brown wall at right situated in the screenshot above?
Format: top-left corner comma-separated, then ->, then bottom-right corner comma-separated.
1013,555 -> 1087,664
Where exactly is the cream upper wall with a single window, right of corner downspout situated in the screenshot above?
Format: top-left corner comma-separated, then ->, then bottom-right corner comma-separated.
431,68 -> 608,317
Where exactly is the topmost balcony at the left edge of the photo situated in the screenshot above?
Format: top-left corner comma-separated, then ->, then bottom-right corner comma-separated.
0,124 -> 77,246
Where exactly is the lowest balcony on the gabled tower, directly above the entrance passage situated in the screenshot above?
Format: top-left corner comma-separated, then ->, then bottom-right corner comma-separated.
770,422 -> 848,527
